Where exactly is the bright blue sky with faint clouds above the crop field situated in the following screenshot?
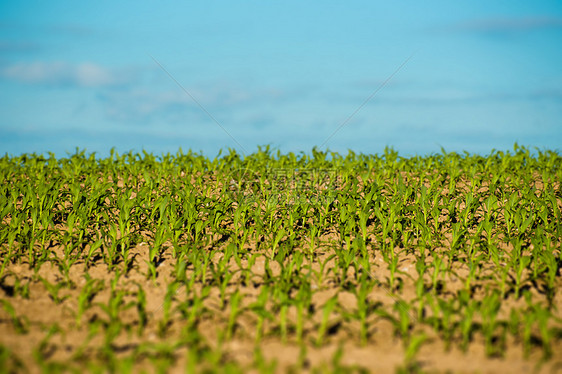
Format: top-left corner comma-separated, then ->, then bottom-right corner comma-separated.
0,0 -> 562,157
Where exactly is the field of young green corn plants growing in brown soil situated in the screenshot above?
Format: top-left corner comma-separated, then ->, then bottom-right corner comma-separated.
0,145 -> 562,373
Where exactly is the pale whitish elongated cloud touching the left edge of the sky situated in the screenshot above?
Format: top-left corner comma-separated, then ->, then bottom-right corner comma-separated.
0,62 -> 131,88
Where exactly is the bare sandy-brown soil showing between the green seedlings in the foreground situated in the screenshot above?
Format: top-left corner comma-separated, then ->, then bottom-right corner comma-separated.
0,170 -> 562,373
